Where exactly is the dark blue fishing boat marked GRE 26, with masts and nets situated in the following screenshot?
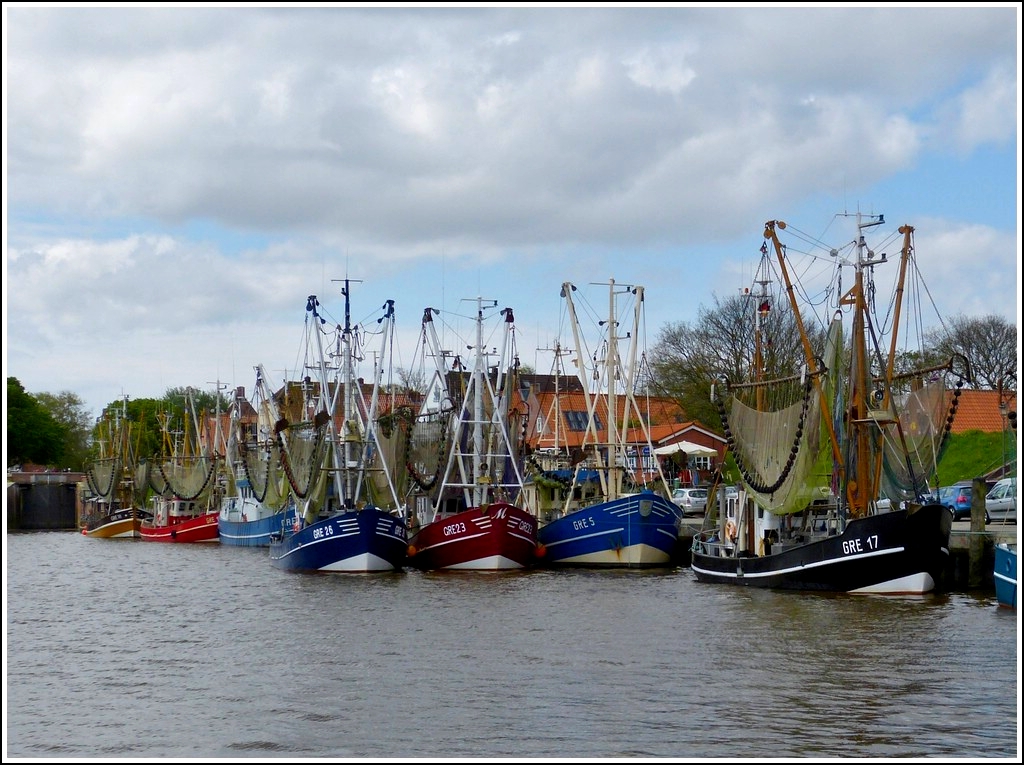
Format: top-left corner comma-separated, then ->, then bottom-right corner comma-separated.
270,279 -> 408,573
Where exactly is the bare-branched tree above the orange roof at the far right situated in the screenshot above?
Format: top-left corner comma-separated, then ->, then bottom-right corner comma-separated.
928,313 -> 1018,390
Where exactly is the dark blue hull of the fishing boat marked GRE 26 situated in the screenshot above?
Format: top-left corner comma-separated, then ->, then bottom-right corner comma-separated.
270,508 -> 409,573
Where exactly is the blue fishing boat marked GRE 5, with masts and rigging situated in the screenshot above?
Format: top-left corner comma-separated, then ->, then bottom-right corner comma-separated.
538,280 -> 682,568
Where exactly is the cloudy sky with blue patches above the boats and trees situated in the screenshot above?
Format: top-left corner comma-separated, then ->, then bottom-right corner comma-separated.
3,3 -> 1021,417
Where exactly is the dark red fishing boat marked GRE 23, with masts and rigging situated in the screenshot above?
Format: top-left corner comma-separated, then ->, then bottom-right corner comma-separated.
409,298 -> 538,571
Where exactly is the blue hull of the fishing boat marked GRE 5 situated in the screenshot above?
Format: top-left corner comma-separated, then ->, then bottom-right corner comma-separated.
537,492 -> 680,568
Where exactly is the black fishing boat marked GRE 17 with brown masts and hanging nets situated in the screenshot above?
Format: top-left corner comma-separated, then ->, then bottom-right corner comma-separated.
691,218 -> 970,595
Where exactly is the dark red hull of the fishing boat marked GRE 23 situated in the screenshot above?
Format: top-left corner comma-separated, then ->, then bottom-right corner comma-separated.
409,502 -> 538,571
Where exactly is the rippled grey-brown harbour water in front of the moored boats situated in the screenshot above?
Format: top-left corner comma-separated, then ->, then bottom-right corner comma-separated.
4,533 -> 1020,761
